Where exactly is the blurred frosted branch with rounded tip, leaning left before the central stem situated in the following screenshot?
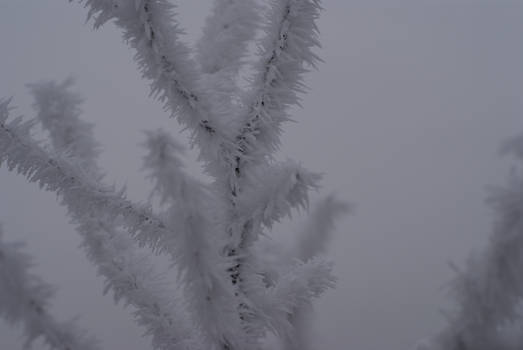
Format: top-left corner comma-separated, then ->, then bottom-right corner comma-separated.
144,130 -> 246,348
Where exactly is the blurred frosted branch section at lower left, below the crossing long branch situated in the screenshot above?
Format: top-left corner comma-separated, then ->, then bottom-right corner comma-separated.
78,220 -> 203,350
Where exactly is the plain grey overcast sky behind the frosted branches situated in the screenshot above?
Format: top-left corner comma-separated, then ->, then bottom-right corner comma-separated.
0,0 -> 523,350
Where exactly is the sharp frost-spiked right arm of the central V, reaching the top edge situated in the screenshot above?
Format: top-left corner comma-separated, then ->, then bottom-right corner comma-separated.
230,0 -> 321,180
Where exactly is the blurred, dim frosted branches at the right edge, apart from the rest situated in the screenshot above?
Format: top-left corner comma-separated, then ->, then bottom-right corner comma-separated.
418,135 -> 523,350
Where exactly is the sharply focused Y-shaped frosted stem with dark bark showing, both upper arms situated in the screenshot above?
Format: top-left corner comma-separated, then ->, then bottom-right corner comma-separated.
72,0 -> 328,340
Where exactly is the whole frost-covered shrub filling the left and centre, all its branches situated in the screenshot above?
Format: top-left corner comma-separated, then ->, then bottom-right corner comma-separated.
0,0 -> 347,350
